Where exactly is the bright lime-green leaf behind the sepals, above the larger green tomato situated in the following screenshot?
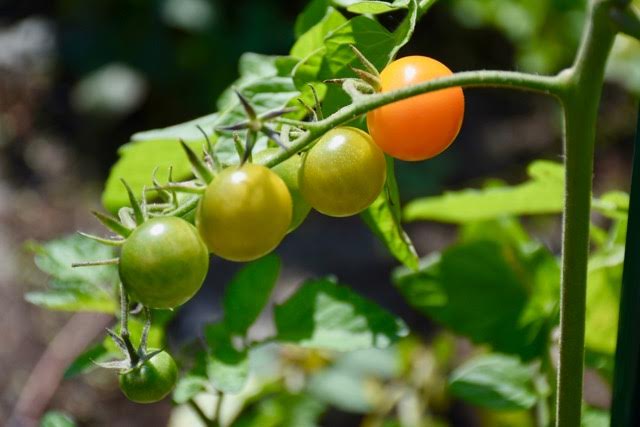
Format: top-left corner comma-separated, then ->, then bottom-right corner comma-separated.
102,139 -> 204,213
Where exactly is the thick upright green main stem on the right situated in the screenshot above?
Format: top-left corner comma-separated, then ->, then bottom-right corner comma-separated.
556,0 -> 615,427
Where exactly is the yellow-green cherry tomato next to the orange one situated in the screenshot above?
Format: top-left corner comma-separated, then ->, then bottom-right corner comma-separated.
300,127 -> 387,217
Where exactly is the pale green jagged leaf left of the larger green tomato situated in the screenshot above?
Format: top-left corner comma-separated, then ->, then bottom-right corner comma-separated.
25,234 -> 119,313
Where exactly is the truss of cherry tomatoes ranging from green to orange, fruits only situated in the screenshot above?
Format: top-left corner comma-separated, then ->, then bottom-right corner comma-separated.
112,56 -> 464,403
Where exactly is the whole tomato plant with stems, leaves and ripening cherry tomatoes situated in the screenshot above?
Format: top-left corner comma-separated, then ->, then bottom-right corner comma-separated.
20,0 -> 640,427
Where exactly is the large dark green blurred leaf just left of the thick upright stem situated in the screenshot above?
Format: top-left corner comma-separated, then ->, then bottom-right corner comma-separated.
394,225 -> 560,359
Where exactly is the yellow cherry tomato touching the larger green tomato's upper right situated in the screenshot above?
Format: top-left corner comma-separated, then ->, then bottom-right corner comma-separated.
196,163 -> 293,261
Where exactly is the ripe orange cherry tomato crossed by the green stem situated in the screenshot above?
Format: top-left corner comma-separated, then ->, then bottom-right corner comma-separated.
367,56 -> 464,161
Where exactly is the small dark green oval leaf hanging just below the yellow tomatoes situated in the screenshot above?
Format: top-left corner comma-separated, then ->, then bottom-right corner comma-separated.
223,255 -> 280,335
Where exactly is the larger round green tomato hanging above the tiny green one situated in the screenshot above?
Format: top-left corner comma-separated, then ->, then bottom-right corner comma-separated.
119,217 -> 209,308
